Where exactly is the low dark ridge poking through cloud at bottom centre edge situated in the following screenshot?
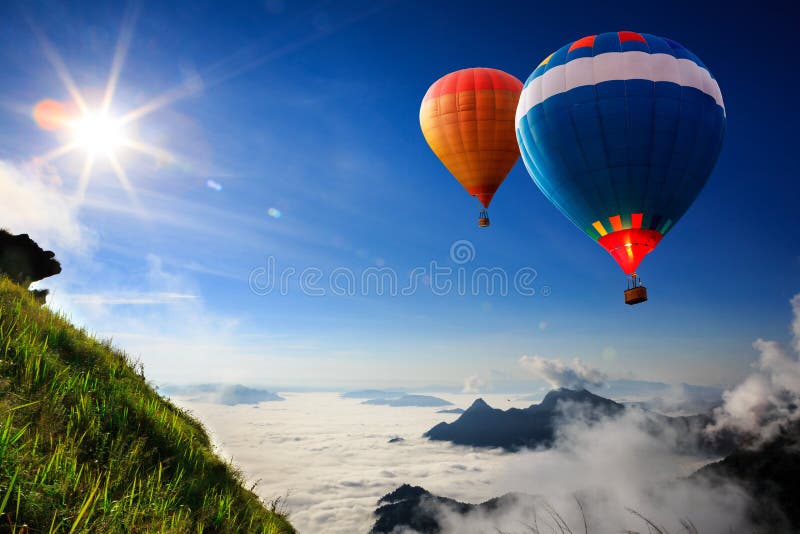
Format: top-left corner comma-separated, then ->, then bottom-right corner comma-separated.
370,484 -> 531,534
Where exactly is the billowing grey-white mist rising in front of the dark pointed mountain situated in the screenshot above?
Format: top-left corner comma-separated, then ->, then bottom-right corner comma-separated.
428,411 -> 752,534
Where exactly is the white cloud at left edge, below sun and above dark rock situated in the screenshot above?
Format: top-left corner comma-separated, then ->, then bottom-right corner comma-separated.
0,160 -> 94,253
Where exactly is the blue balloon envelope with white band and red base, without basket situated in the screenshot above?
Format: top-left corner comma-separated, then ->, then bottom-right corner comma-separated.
515,32 -> 725,274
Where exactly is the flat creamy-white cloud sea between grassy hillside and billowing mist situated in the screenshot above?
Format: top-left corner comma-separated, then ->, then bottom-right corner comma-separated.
180,392 -> 528,534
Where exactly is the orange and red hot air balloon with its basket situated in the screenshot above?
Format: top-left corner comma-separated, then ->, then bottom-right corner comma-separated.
419,68 -> 522,226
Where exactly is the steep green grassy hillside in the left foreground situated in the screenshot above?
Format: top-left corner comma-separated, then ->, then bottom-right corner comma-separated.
0,278 -> 294,534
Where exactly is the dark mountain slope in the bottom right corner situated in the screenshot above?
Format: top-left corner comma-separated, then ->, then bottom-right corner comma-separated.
692,422 -> 800,533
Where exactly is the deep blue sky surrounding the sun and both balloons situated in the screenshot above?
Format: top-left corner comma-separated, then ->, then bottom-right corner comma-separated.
0,0 -> 800,388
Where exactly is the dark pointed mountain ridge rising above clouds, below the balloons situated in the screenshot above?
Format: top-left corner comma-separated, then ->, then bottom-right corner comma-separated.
425,388 -> 625,450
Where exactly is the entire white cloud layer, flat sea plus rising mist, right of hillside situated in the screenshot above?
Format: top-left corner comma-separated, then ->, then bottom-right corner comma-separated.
173,393 -> 748,534
